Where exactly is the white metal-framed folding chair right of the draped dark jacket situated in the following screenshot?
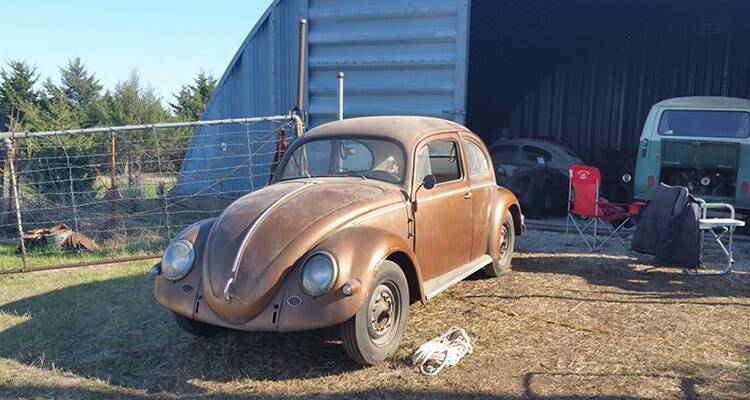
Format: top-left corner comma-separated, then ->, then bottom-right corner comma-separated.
685,198 -> 745,275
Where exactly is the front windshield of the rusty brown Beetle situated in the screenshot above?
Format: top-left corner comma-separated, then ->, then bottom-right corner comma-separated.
280,138 -> 406,183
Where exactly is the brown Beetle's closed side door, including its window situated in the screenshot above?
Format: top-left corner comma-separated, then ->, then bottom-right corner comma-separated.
413,133 -> 472,280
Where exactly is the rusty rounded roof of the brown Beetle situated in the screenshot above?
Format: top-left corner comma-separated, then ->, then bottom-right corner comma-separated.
305,116 -> 478,148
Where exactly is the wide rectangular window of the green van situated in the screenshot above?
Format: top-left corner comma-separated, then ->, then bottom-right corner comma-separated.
659,110 -> 750,138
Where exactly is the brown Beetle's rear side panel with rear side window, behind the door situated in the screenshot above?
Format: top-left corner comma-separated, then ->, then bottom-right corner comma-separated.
462,136 -> 497,260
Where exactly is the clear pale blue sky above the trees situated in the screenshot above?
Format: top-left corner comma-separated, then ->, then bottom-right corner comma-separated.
0,0 -> 271,101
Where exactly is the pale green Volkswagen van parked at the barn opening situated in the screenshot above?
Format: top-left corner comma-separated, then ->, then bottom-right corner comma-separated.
636,97 -> 750,214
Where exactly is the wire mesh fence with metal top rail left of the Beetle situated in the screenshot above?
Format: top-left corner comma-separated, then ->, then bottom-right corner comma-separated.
0,116 -> 301,273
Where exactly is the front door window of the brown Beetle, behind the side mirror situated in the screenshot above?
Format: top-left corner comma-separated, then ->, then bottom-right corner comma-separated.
414,140 -> 461,183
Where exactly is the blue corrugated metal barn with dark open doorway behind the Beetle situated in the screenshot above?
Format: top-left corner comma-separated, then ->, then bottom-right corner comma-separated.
181,0 -> 750,195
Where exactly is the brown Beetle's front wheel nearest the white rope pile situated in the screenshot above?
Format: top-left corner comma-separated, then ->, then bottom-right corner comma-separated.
341,261 -> 409,365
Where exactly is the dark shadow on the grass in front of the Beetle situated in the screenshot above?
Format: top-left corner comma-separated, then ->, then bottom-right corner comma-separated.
0,275 -> 360,392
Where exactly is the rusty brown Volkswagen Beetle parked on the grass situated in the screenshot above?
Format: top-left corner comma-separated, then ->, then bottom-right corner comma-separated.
152,117 -> 524,365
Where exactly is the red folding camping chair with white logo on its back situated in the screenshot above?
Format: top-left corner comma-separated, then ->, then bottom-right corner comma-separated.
566,164 -> 641,251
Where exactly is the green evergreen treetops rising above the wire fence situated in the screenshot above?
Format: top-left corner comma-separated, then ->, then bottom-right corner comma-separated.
0,58 -> 216,131
